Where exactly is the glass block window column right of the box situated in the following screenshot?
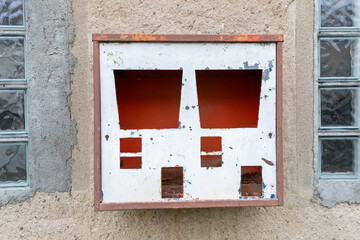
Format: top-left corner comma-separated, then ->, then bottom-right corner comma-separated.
315,0 -> 360,180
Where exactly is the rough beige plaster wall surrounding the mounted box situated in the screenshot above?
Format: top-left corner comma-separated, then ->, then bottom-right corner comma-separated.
0,0 -> 360,240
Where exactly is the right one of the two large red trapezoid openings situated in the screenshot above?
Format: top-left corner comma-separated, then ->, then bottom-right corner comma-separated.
196,70 -> 262,128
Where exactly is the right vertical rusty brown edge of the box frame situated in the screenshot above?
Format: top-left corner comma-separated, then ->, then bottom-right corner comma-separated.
276,42 -> 284,206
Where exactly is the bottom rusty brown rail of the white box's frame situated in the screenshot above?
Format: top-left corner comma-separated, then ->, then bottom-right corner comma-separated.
100,200 -> 279,211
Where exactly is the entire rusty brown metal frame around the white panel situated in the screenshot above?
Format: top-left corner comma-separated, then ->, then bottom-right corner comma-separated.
92,34 -> 284,211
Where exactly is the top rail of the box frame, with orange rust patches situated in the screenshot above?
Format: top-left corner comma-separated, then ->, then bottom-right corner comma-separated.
92,33 -> 284,42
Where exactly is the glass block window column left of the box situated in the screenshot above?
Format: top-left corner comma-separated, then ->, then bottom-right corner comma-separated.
0,0 -> 29,188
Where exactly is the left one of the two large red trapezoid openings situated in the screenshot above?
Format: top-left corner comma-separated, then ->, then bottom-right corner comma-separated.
114,70 -> 182,129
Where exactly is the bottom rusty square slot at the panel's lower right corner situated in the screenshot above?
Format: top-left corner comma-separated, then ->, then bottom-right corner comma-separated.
241,166 -> 262,197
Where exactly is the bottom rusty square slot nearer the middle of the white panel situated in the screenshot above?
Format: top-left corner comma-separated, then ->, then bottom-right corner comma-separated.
161,167 -> 184,198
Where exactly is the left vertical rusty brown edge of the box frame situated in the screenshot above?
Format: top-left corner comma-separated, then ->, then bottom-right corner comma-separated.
93,41 -> 102,210
